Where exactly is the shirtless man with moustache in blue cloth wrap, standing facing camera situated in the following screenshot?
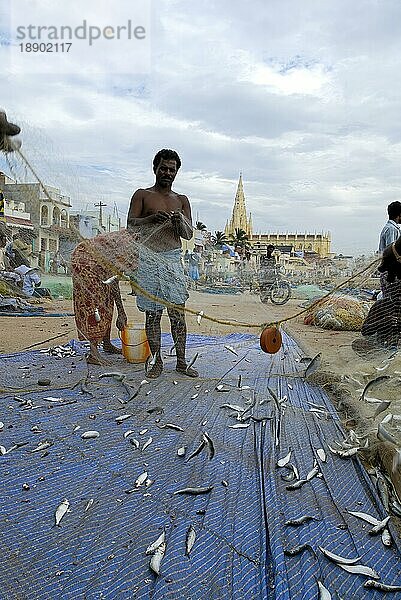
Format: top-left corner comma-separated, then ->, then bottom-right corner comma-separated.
128,149 -> 198,379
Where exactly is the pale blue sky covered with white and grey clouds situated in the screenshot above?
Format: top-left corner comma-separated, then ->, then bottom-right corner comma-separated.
0,0 -> 401,255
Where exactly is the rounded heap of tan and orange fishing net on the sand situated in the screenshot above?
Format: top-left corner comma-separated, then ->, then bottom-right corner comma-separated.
304,295 -> 370,331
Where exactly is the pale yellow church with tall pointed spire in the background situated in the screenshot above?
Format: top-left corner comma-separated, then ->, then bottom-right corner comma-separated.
224,174 -> 332,258
